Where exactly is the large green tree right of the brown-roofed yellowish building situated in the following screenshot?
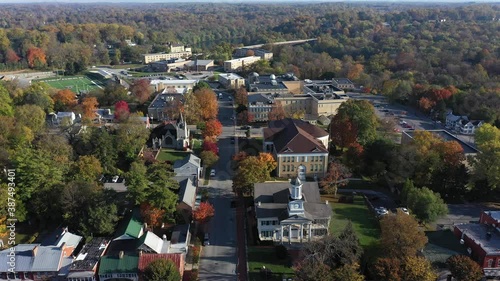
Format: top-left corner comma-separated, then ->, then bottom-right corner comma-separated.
336,99 -> 378,145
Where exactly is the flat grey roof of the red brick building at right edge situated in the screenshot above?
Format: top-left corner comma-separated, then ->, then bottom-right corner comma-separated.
455,223 -> 500,255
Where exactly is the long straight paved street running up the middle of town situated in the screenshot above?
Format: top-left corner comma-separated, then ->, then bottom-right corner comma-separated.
199,93 -> 244,281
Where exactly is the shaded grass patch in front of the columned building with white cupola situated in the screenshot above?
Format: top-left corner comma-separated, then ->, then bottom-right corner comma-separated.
247,247 -> 293,281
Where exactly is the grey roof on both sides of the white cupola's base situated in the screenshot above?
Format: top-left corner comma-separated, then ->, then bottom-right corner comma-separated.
254,182 -> 332,220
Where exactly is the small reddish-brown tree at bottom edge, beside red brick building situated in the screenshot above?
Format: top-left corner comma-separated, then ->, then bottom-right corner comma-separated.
446,255 -> 483,281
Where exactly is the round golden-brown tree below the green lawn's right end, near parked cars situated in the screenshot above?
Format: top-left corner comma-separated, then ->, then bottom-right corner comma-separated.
380,212 -> 427,258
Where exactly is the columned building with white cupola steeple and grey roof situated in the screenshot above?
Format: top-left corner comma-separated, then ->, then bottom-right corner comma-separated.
254,177 -> 332,244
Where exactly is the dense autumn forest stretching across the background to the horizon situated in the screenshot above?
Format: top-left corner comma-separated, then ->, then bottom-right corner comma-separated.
0,3 -> 500,122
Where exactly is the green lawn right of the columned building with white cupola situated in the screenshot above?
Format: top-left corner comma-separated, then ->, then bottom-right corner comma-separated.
323,196 -> 380,247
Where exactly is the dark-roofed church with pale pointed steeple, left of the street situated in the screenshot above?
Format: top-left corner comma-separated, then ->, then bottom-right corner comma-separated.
148,114 -> 190,150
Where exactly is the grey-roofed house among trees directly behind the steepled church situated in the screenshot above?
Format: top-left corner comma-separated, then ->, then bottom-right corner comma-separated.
148,93 -> 185,121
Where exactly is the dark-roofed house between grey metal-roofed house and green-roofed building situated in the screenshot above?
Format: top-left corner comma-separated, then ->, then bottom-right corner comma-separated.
66,237 -> 109,281
